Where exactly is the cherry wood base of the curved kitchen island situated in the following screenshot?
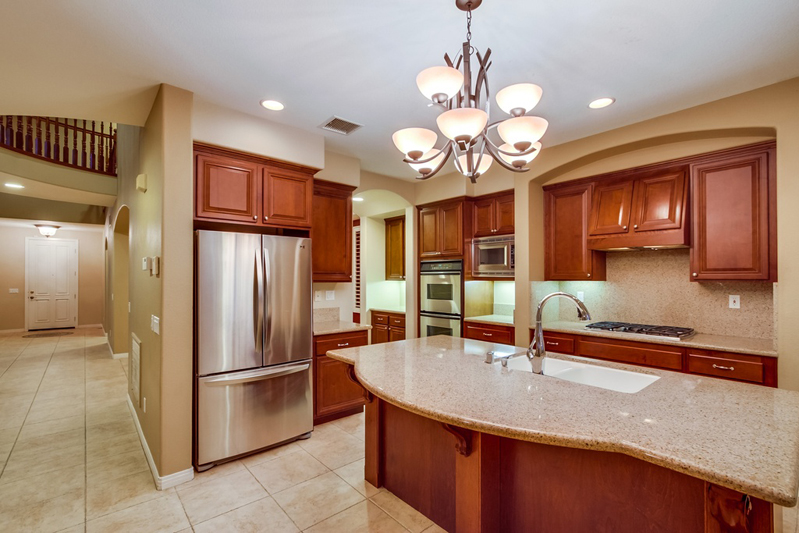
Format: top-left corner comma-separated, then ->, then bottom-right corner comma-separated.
364,396 -> 773,533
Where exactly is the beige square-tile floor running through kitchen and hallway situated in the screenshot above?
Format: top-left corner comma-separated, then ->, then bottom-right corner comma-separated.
0,328 -> 450,533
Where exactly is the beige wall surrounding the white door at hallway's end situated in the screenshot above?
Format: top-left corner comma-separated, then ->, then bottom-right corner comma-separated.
0,222 -> 105,330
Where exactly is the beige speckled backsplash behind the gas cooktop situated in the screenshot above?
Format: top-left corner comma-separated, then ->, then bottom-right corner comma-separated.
531,249 -> 775,339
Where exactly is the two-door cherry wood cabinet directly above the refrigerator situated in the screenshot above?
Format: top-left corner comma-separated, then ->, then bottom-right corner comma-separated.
194,143 -> 316,230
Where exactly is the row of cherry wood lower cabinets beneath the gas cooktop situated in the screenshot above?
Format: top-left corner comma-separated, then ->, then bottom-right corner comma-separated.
530,329 -> 777,387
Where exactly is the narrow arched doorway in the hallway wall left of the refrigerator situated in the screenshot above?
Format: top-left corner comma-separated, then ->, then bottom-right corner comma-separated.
111,205 -> 130,357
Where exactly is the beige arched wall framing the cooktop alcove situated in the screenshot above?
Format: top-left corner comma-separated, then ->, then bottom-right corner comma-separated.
515,78 -> 799,390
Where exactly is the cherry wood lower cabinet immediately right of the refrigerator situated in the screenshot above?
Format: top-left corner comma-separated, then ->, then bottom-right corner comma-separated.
313,330 -> 369,425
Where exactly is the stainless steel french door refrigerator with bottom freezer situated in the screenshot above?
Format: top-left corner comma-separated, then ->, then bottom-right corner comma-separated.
195,230 -> 313,470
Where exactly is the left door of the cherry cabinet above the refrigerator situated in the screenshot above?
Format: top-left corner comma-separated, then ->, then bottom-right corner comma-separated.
195,155 -> 260,224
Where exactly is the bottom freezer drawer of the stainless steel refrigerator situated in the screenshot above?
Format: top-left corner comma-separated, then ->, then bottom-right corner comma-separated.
197,360 -> 313,466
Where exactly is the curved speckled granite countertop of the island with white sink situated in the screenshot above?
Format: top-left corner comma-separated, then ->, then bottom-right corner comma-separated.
327,336 -> 799,507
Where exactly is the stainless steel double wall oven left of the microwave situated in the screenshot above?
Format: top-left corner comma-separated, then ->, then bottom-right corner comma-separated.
419,260 -> 463,337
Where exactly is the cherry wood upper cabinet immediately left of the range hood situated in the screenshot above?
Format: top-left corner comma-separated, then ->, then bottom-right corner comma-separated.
544,183 -> 605,280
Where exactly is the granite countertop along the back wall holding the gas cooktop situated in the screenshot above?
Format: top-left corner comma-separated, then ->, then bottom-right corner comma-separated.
532,320 -> 777,357
